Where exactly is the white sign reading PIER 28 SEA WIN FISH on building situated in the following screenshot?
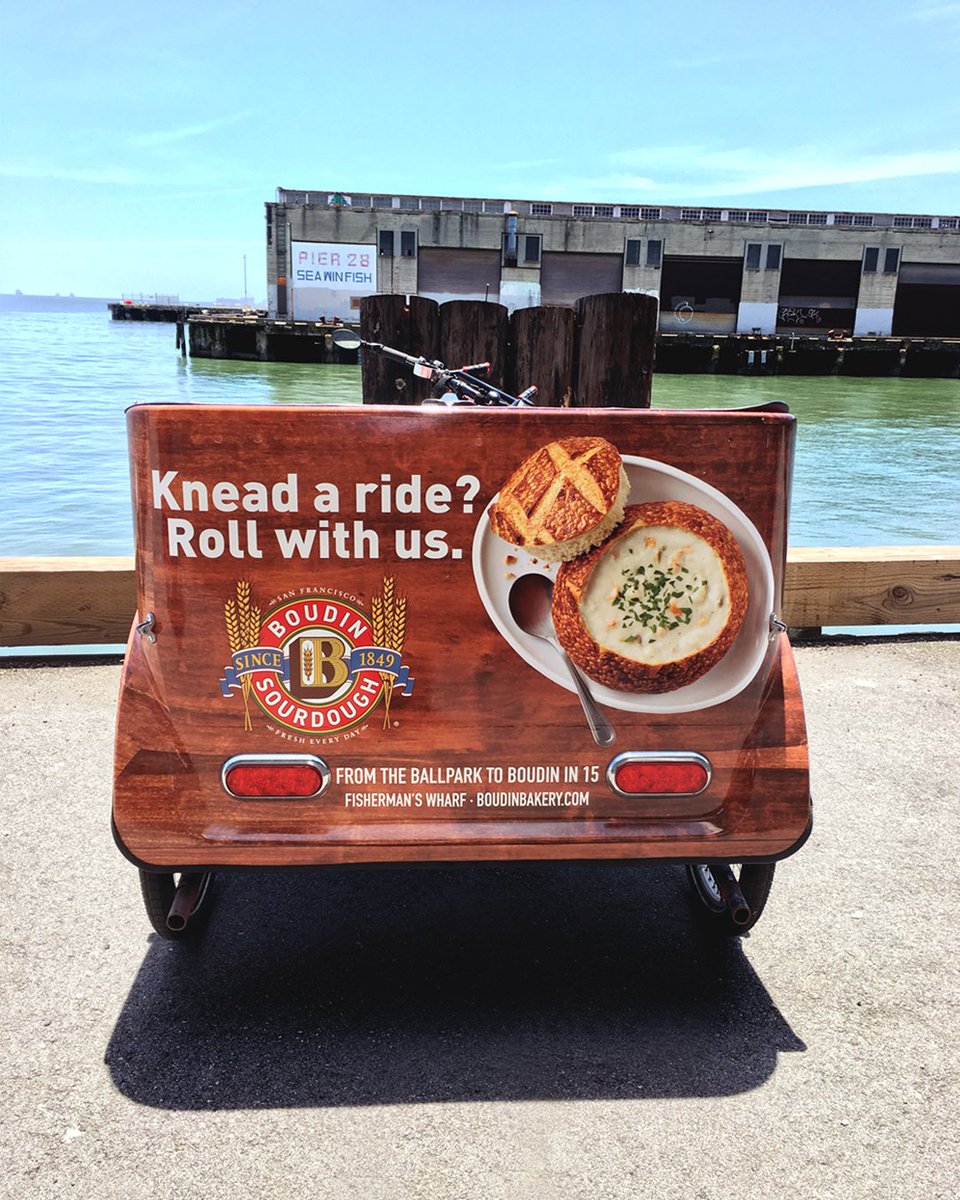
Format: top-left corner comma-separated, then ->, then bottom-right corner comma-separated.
290,241 -> 377,320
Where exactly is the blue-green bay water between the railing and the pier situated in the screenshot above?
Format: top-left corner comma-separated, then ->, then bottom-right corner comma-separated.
0,308 -> 960,638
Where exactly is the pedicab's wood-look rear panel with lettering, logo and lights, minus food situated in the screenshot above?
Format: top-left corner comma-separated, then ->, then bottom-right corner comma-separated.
114,404 -> 810,871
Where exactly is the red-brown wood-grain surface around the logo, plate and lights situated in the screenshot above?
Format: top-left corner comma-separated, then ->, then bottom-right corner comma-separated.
114,406 -> 809,866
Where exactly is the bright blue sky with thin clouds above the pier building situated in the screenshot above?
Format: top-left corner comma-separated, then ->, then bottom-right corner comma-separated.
0,0 -> 960,299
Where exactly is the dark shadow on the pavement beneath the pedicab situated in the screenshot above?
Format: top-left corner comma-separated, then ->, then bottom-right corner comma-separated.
107,864 -> 805,1109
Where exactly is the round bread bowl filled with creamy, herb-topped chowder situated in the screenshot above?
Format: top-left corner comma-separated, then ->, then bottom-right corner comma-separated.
553,500 -> 749,692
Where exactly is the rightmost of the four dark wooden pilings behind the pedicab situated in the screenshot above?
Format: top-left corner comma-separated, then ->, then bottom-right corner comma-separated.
574,292 -> 658,408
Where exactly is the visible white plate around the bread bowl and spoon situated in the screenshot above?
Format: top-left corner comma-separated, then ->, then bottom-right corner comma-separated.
473,455 -> 774,713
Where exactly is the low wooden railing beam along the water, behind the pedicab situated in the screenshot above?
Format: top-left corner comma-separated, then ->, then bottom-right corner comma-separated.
0,546 -> 960,648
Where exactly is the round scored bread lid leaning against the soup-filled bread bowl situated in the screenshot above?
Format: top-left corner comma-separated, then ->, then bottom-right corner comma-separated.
490,438 -> 630,562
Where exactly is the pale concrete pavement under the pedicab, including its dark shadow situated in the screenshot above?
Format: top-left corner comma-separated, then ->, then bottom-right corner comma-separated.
0,640 -> 960,1200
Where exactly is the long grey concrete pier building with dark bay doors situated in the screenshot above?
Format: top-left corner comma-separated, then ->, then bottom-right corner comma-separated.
266,188 -> 960,338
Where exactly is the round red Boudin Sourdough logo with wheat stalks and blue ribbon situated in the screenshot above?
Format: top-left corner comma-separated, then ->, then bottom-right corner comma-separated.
220,578 -> 413,737
